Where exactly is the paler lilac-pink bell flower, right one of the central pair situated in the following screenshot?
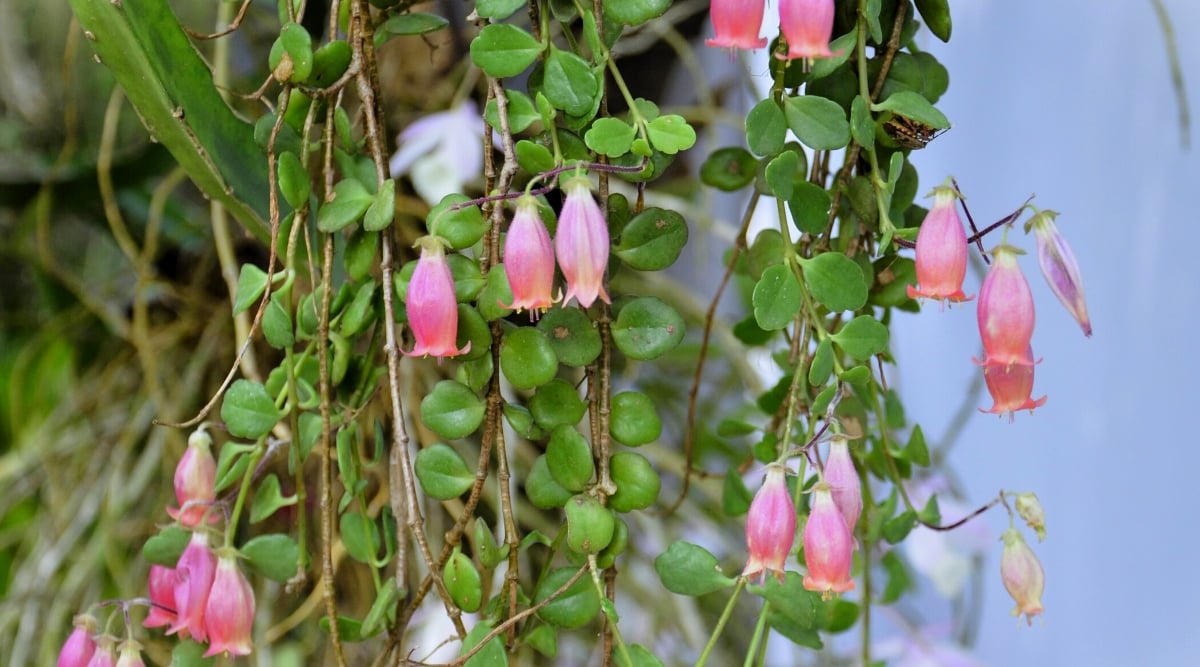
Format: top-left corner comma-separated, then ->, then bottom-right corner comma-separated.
554,176 -> 612,308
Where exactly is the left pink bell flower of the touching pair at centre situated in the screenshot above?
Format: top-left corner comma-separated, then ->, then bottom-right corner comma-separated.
502,194 -> 554,319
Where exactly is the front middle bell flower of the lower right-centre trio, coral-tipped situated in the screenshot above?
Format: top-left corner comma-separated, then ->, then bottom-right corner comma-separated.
803,481 -> 854,600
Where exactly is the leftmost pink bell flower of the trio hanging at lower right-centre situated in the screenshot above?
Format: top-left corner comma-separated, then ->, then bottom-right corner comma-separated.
742,464 -> 796,582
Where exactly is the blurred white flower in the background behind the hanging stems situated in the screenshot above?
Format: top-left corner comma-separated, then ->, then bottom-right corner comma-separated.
391,100 -> 484,204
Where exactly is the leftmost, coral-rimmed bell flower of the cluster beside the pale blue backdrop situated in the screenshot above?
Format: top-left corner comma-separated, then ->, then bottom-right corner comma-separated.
908,185 -> 974,306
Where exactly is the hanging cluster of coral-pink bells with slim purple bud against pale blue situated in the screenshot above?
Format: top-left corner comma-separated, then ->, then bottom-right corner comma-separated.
907,179 -> 1092,421
